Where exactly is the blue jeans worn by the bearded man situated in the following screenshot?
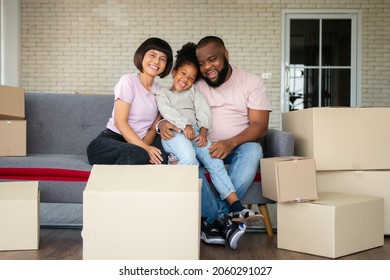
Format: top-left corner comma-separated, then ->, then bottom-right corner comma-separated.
199,142 -> 263,224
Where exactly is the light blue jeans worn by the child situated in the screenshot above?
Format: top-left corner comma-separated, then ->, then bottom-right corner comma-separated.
162,129 -> 236,200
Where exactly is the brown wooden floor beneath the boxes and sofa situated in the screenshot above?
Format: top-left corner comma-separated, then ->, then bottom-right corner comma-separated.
0,229 -> 390,260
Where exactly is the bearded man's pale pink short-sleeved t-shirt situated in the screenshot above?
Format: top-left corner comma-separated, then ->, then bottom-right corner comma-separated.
195,67 -> 272,141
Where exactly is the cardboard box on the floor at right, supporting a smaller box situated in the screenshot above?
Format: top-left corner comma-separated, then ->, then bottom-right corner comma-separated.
277,193 -> 384,258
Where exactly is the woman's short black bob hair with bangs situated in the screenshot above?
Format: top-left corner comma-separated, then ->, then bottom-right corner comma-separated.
133,37 -> 173,78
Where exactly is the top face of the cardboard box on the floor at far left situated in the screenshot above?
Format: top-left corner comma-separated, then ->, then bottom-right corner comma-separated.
0,181 -> 39,201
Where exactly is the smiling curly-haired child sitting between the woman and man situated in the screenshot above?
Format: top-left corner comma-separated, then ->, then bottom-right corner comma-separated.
154,43 -> 262,222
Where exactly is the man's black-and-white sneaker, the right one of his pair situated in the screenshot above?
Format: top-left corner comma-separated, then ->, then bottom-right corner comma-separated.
214,215 -> 246,250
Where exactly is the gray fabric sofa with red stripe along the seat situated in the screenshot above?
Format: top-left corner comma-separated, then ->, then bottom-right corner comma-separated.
0,93 -> 294,230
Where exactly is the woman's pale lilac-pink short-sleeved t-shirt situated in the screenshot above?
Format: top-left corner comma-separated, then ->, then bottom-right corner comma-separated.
107,74 -> 161,139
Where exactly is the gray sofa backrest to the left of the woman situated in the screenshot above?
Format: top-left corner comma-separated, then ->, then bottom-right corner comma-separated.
25,93 -> 114,155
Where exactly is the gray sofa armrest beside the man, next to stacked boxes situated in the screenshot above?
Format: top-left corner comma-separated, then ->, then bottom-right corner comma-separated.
263,128 -> 294,157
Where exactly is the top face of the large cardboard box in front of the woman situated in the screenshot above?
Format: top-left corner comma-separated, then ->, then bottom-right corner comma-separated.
85,164 -> 199,192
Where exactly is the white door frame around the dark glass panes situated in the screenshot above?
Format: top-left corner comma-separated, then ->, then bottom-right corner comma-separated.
280,9 -> 362,113
